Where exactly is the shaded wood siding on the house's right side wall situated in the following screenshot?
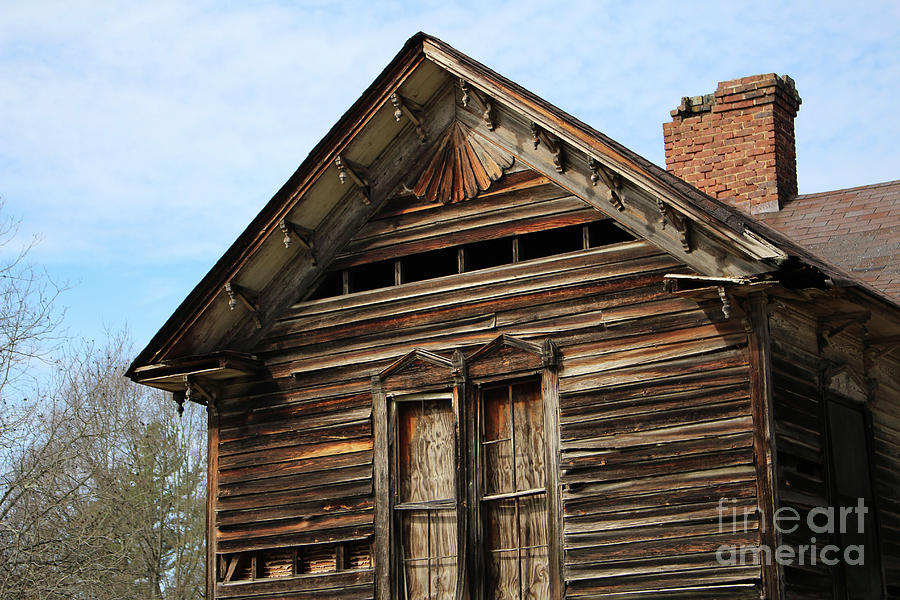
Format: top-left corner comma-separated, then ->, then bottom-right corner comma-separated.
770,302 -> 900,600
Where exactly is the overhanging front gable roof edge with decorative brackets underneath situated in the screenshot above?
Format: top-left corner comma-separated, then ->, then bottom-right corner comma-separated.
127,33 -> 900,389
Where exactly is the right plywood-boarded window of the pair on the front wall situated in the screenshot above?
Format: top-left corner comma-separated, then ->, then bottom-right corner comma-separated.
481,382 -> 550,599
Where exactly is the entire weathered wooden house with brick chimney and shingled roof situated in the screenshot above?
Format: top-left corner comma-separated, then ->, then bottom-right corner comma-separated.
128,34 -> 900,600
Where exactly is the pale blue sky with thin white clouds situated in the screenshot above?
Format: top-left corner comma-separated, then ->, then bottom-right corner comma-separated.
0,0 -> 900,354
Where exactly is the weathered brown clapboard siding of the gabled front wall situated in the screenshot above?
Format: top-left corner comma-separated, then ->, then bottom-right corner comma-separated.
216,174 -> 760,600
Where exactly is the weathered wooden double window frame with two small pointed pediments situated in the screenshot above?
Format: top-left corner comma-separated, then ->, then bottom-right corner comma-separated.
371,335 -> 564,600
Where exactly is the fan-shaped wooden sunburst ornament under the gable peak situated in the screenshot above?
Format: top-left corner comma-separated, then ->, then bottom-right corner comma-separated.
413,122 -> 515,204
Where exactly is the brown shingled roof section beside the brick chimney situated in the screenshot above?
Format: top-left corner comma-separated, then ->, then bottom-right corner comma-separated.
756,180 -> 900,301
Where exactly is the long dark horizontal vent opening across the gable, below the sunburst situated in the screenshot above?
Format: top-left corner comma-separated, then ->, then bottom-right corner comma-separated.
306,219 -> 635,300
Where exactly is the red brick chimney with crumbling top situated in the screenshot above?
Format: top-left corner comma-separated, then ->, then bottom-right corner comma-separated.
663,73 -> 800,214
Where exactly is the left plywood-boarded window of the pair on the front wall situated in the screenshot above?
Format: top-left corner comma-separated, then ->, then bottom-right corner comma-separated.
393,395 -> 457,600
